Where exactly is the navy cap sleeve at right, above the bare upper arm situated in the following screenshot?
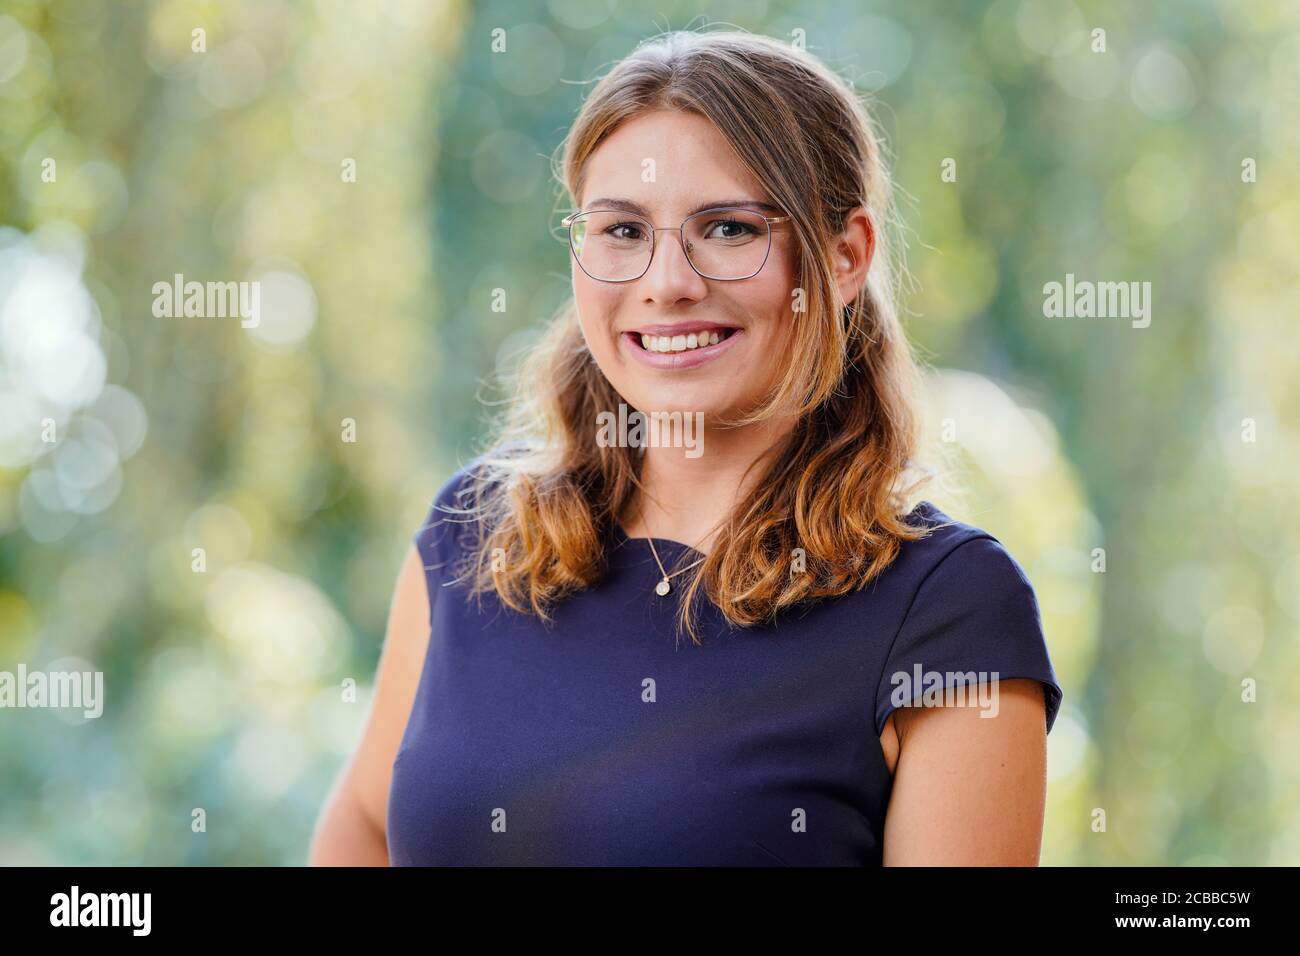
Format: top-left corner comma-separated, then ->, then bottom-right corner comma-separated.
875,536 -> 1062,735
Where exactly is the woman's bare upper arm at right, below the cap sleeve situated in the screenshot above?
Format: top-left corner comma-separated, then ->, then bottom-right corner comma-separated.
884,680 -> 1047,866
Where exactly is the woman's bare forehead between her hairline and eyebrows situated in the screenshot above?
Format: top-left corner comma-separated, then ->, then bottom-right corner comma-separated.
579,111 -> 771,215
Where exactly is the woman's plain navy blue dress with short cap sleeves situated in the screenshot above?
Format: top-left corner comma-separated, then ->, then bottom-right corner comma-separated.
387,463 -> 1061,866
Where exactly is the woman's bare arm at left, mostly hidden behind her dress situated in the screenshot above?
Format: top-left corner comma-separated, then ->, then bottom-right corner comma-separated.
308,546 -> 429,866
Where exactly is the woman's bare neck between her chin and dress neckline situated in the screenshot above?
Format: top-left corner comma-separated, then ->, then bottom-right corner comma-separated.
621,418 -> 793,554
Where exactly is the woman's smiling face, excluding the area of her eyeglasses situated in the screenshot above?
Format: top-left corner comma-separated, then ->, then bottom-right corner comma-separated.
569,111 -> 796,418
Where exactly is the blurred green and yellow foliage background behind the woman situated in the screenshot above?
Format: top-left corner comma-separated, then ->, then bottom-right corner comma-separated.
0,0 -> 1300,865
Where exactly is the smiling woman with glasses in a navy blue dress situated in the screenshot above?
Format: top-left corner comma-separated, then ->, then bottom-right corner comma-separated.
312,33 -> 1061,865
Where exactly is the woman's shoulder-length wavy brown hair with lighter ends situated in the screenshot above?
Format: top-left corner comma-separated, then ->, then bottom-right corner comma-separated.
452,31 -> 933,644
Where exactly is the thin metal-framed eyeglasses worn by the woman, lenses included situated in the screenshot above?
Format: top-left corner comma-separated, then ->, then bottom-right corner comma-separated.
560,206 -> 790,282
